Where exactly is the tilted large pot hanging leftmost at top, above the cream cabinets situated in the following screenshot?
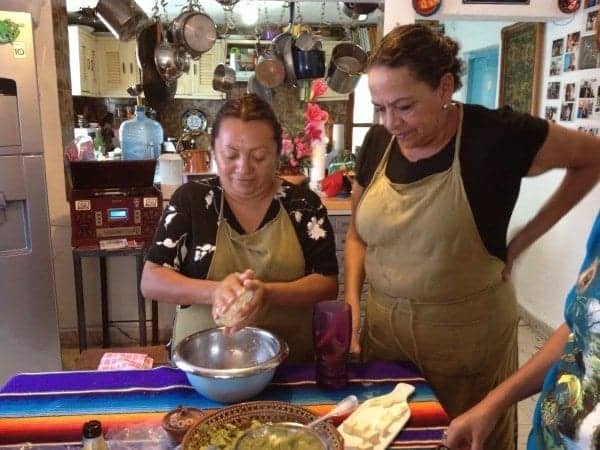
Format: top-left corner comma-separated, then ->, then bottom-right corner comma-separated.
95,0 -> 150,41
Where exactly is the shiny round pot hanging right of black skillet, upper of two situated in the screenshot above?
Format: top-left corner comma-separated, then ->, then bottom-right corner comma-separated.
170,11 -> 217,58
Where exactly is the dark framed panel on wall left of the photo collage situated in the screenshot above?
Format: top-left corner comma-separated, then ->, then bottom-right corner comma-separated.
498,23 -> 544,115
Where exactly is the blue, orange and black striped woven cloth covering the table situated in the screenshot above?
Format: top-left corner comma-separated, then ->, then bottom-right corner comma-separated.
0,362 -> 448,449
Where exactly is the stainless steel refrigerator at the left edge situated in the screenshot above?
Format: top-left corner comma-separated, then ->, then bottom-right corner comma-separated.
0,5 -> 61,386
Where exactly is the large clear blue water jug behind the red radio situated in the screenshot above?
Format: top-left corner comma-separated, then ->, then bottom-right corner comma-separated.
119,105 -> 163,163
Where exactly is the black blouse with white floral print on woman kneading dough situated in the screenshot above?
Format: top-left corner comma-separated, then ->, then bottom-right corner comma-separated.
146,177 -> 338,279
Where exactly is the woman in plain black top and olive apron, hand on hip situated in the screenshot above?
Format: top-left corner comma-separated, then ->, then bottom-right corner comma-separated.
345,24 -> 600,450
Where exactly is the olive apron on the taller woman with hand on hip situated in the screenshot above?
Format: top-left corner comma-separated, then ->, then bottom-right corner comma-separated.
355,107 -> 518,450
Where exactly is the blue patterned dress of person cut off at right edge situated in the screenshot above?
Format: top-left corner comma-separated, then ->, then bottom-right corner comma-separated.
527,215 -> 600,450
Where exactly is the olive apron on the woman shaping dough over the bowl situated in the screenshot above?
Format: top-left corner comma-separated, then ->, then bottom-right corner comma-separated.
173,195 -> 314,363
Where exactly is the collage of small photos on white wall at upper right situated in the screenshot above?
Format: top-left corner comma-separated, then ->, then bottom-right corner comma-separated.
544,0 -> 600,130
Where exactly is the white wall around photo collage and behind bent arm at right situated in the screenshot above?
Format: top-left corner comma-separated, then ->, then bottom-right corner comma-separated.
510,2 -> 600,327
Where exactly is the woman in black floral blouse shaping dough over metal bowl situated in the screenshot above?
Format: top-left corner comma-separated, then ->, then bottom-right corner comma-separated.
141,95 -> 338,362
